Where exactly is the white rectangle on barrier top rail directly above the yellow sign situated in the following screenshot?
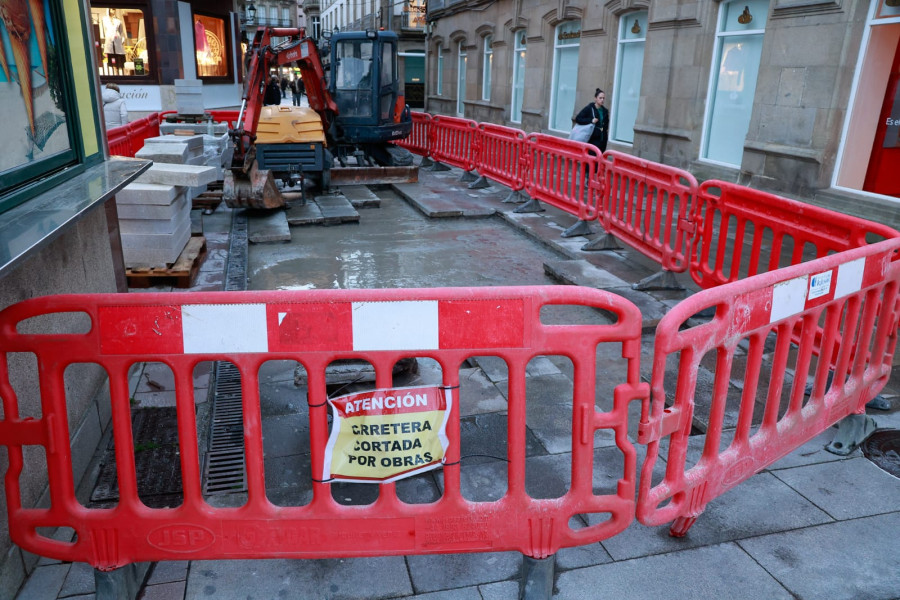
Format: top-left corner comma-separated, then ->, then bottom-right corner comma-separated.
353,301 -> 438,350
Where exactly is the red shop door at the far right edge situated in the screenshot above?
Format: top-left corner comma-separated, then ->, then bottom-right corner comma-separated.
863,38 -> 900,198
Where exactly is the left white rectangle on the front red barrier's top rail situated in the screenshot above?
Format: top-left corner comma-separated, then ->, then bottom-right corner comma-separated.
181,304 -> 269,354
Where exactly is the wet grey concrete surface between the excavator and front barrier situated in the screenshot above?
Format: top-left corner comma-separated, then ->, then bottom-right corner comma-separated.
247,190 -> 560,290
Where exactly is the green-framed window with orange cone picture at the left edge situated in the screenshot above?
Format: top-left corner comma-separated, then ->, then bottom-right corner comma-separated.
0,0 -> 78,211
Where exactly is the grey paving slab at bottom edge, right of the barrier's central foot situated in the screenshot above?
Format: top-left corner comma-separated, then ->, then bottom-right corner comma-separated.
553,544 -> 792,600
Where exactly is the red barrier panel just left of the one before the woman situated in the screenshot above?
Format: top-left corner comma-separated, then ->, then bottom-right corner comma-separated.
475,123 -> 525,192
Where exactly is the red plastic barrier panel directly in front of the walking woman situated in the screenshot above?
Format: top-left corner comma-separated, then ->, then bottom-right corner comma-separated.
523,133 -> 605,221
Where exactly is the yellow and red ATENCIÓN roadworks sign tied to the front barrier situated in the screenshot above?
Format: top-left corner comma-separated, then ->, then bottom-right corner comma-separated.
323,387 -> 453,483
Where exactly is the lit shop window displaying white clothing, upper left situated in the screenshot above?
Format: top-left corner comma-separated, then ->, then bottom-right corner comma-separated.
91,5 -> 156,81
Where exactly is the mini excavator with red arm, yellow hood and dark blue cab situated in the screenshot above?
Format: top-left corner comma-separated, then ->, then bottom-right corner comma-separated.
223,27 -> 417,209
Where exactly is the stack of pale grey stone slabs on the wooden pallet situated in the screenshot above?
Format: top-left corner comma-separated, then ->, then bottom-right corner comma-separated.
116,163 -> 216,268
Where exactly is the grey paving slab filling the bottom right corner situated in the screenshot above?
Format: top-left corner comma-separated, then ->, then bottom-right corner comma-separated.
738,512 -> 900,600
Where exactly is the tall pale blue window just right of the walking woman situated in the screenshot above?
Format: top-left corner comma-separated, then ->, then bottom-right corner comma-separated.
611,11 -> 647,144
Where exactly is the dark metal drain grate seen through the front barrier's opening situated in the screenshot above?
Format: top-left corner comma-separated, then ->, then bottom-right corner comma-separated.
203,362 -> 247,495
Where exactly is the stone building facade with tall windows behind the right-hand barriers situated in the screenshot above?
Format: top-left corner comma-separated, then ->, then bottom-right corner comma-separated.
426,0 -> 900,226
